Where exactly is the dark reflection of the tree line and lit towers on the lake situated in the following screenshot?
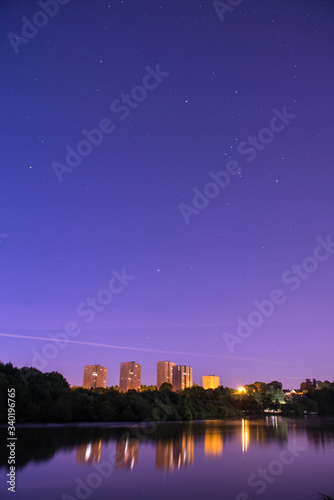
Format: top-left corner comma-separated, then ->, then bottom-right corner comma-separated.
0,416 -> 334,471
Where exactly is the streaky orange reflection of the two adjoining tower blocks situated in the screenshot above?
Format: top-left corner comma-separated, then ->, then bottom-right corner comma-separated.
155,433 -> 194,471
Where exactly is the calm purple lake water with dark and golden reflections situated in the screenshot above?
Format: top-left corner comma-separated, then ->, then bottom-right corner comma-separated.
0,417 -> 334,500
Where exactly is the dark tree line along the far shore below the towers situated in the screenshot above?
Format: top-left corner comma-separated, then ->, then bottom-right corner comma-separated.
0,362 -> 334,423
